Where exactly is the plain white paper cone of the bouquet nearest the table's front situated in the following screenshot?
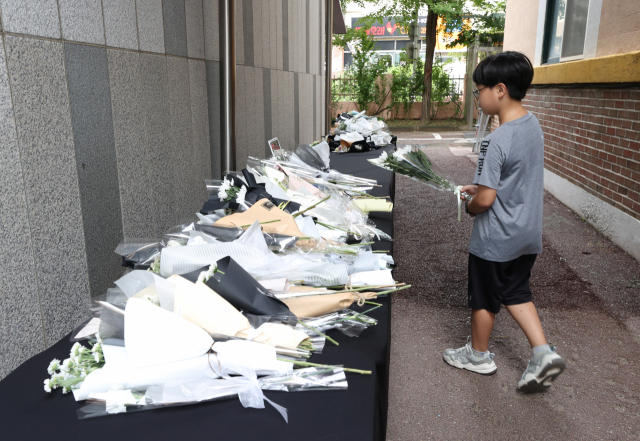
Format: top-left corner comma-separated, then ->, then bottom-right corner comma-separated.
124,299 -> 213,368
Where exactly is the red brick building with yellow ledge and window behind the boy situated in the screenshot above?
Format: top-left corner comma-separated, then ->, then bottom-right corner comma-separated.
500,0 -> 640,260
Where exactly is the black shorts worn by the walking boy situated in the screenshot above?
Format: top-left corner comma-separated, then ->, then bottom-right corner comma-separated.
469,253 -> 537,314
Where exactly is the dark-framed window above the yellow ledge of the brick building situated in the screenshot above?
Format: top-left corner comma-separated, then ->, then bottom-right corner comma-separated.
542,0 -> 589,64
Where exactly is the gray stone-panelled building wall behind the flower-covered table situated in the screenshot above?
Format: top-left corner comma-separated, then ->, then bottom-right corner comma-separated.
0,0 -> 326,378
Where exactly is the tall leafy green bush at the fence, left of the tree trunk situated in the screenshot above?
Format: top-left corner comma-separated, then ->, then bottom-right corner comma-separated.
333,28 -> 391,114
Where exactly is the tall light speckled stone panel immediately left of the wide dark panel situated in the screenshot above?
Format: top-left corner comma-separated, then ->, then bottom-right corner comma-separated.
6,37 -> 89,345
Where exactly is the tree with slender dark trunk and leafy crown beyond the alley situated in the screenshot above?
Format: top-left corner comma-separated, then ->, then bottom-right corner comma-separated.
343,0 -> 492,123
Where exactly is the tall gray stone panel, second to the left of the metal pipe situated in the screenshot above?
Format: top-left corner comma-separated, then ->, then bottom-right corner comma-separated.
163,57 -> 195,228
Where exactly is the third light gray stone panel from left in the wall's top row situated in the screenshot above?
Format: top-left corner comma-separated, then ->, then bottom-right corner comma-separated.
102,0 -> 138,50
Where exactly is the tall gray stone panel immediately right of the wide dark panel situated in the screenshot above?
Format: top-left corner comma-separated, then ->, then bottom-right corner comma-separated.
107,50 -> 157,239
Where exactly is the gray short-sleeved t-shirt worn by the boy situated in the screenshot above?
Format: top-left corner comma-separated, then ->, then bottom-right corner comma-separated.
469,113 -> 544,262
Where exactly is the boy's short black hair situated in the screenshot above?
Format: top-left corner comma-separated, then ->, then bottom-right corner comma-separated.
473,51 -> 533,101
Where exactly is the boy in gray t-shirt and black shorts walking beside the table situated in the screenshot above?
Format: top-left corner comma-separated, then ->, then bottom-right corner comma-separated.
444,52 -> 565,392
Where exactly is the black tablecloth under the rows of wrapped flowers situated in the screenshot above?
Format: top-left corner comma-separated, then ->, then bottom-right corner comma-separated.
0,152 -> 393,441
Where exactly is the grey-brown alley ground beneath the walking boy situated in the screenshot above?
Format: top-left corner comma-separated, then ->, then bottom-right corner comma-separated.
387,140 -> 640,441
